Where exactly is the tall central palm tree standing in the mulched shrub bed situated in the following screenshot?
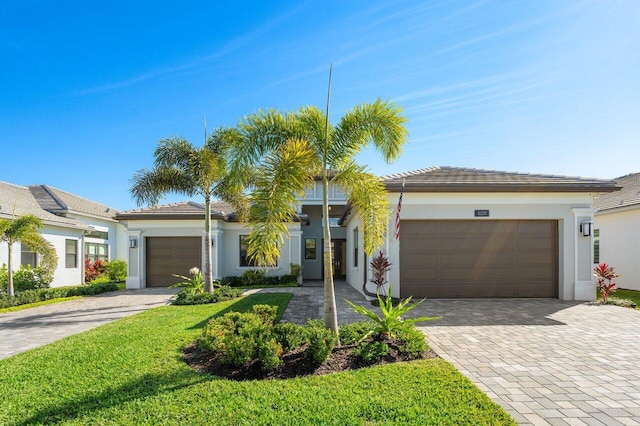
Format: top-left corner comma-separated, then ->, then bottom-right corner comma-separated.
229,99 -> 407,333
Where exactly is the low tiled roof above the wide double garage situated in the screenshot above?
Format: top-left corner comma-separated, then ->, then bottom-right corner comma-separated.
382,166 -> 617,192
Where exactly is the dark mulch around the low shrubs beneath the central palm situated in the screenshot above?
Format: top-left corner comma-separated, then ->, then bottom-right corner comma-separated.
183,342 -> 439,381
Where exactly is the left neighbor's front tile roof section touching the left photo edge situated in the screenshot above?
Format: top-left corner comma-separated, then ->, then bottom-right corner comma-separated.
0,182 -> 88,229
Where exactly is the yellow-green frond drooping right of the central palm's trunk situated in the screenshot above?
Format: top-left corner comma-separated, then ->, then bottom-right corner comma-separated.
332,163 -> 390,256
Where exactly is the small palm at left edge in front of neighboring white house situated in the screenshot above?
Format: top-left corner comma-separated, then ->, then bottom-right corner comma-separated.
0,214 -> 58,296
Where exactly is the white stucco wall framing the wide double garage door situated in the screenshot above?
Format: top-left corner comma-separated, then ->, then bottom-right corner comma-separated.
347,193 -> 595,300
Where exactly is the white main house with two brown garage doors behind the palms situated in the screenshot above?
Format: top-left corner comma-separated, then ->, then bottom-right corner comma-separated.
116,167 -> 616,300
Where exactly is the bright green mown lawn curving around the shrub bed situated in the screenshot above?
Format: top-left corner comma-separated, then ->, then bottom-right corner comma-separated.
0,293 -> 515,425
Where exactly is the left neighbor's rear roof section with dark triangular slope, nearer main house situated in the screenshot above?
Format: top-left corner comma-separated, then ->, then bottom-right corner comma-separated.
29,185 -> 117,220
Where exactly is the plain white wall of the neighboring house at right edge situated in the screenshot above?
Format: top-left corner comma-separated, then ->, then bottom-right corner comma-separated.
594,206 -> 640,290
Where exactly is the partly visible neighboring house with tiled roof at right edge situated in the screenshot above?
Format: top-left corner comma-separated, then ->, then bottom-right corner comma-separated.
594,173 -> 640,290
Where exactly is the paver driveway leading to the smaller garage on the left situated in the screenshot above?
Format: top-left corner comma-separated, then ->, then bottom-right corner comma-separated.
0,288 -> 177,359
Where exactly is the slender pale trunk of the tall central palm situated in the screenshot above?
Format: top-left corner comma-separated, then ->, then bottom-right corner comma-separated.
322,173 -> 340,345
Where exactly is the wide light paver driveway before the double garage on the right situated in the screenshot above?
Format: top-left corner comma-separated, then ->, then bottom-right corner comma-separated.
411,299 -> 640,426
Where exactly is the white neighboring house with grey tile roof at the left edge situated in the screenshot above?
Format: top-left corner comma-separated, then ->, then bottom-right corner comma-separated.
0,182 -> 122,287
